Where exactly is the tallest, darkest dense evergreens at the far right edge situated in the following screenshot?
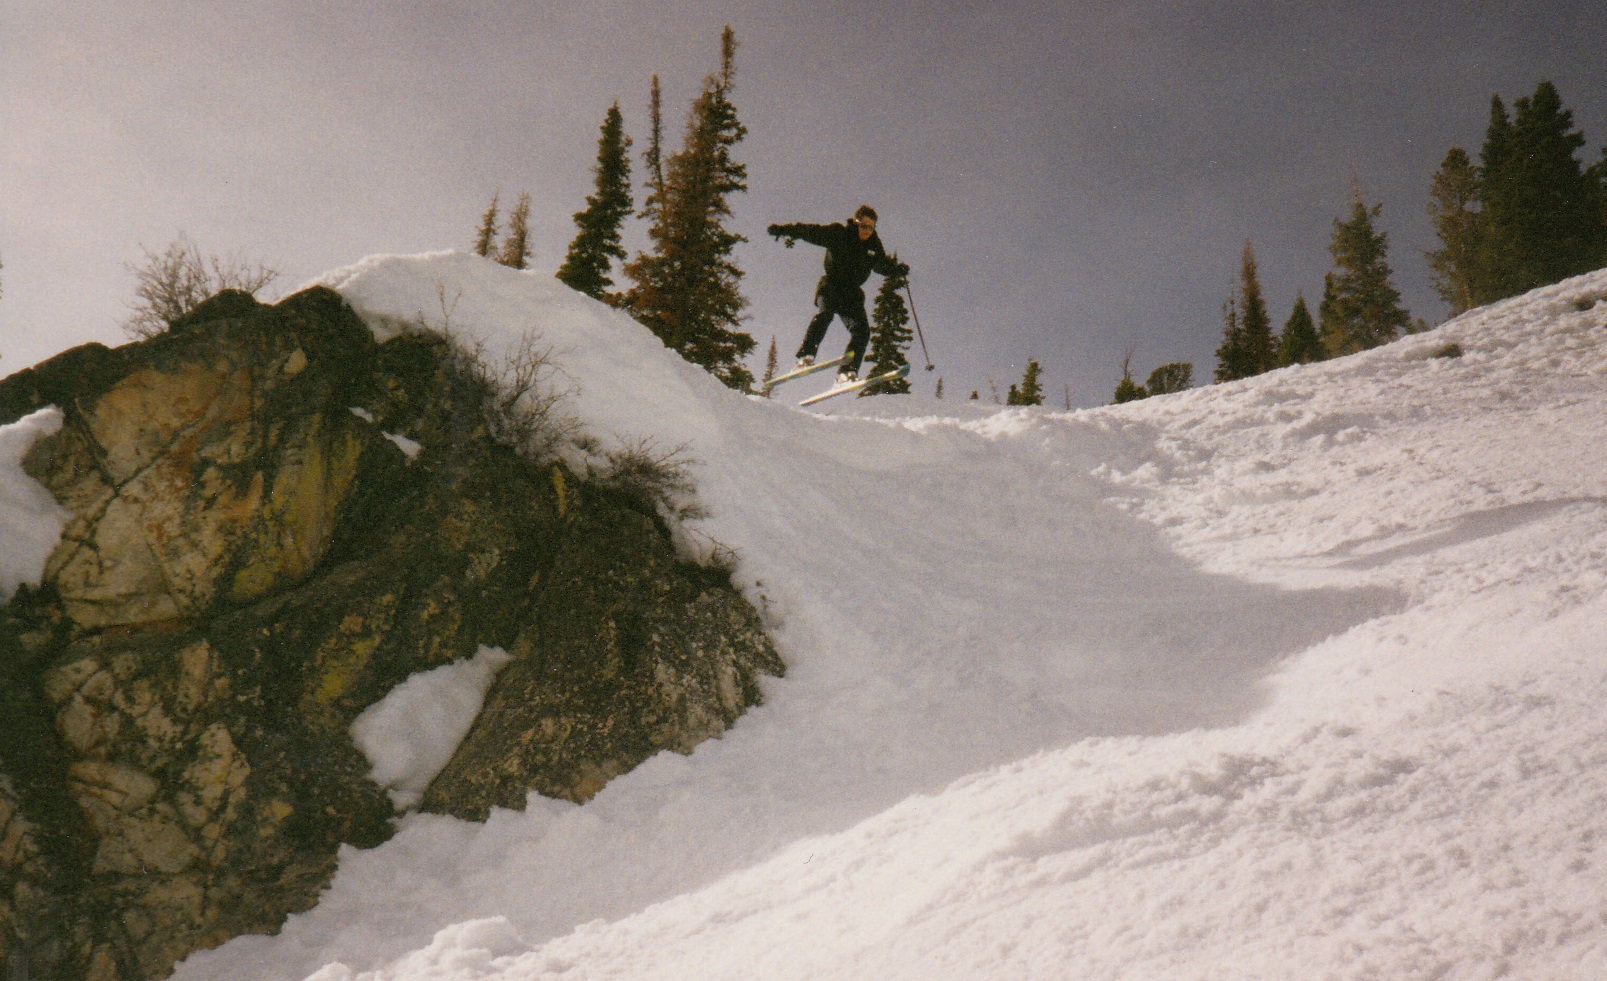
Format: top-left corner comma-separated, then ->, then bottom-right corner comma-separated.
1478,82 -> 1607,299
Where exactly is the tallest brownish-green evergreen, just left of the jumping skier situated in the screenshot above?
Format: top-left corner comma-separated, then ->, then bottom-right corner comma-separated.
625,27 -> 754,389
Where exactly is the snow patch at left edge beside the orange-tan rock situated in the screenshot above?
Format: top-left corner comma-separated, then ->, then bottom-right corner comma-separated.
0,407 -> 71,603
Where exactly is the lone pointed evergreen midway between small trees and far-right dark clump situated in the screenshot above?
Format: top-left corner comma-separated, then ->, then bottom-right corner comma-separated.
1318,187 -> 1411,357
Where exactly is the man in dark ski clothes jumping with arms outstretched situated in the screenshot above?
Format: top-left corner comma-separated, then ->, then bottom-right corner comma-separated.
767,204 -> 910,384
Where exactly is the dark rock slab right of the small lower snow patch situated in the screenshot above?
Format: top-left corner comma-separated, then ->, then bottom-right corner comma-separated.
423,492 -> 783,819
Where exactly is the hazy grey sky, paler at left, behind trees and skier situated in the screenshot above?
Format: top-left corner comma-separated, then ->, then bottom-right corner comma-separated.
0,0 -> 1607,405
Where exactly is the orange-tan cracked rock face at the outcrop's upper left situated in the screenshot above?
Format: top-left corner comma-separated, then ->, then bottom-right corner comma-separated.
20,291 -> 373,629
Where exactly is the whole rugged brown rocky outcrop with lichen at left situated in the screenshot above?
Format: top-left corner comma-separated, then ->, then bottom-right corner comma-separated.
0,288 -> 781,979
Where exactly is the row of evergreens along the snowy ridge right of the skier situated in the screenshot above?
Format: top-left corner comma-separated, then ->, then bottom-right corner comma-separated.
1112,82 -> 1607,402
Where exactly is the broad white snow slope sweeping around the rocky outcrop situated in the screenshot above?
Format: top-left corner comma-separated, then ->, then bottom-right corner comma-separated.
177,254 -> 1607,981
